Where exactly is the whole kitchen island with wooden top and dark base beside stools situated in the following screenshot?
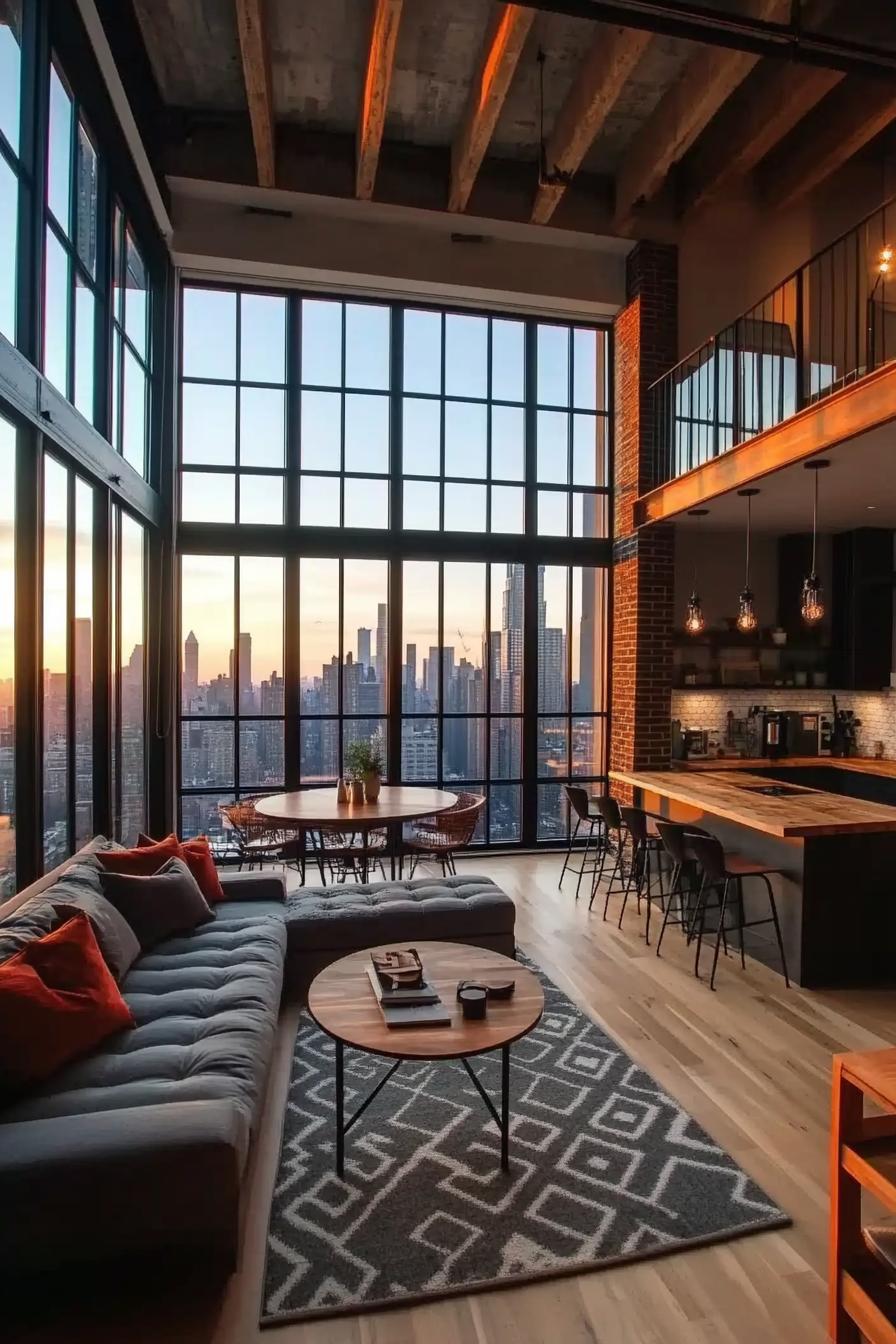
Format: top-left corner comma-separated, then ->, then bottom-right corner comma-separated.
610,757 -> 896,989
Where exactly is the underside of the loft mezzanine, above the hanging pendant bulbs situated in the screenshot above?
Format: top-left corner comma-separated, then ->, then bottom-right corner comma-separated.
672,421 -> 896,532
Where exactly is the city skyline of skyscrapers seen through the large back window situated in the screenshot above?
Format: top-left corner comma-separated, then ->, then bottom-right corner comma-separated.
181,563 -> 602,841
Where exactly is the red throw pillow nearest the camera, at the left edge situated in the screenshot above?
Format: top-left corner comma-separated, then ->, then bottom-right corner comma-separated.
0,910 -> 134,1091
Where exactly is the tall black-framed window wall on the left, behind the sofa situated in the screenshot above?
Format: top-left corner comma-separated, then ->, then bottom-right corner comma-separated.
0,0 -> 168,899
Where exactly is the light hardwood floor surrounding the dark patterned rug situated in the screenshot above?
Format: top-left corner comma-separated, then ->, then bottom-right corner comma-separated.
16,855 -> 896,1344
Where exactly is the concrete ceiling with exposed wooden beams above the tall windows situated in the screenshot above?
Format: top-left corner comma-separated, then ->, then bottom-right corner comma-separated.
120,0 -> 896,238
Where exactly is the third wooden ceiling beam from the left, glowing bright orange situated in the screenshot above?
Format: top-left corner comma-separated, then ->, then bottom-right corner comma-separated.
449,4 -> 535,210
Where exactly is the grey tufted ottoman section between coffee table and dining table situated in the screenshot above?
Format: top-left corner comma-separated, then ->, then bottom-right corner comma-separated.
286,876 -> 516,993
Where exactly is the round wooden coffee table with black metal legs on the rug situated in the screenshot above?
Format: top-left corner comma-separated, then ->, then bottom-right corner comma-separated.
308,942 -> 544,1176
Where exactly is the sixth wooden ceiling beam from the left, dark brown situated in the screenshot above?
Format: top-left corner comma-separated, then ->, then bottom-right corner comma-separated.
681,62 -> 844,210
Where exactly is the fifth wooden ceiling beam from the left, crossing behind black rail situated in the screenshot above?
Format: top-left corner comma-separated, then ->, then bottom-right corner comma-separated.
615,0 -> 780,233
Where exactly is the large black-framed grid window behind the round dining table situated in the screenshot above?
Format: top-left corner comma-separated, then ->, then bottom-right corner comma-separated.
179,284 -> 610,844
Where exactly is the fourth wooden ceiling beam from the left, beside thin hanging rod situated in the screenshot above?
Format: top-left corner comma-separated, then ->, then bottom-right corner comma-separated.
532,28 -> 652,224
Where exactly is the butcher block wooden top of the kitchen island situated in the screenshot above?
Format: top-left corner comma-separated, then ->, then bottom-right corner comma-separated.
610,758 -> 896,839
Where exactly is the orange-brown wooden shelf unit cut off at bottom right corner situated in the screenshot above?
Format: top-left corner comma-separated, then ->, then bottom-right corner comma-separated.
827,1050 -> 896,1344
